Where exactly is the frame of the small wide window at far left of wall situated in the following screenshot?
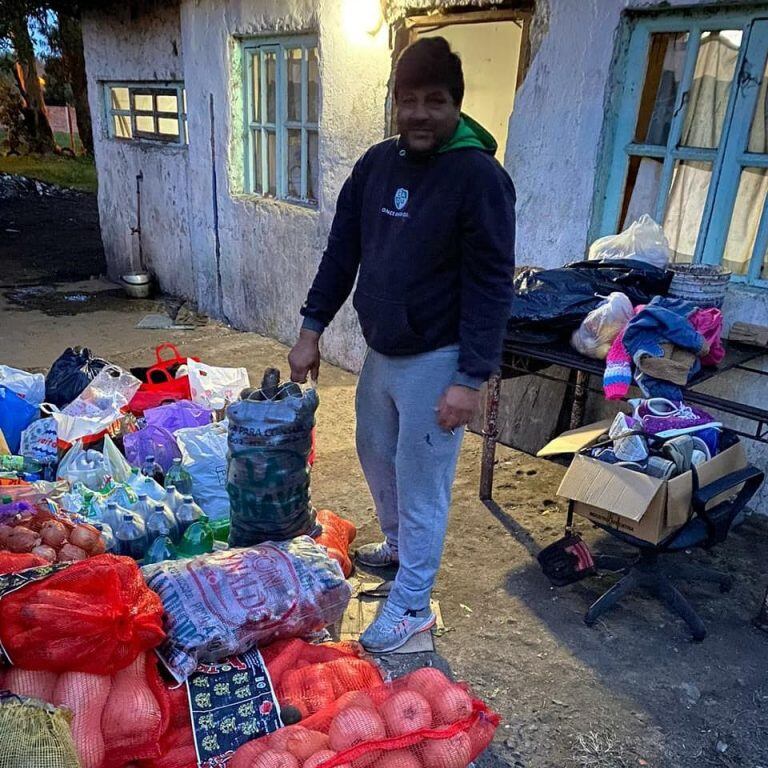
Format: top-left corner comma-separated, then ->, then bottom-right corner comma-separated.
103,80 -> 187,146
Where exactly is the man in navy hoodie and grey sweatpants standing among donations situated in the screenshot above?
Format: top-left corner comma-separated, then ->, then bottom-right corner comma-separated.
288,37 -> 515,653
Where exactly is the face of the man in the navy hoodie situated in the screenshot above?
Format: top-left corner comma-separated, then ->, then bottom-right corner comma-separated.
397,86 -> 461,152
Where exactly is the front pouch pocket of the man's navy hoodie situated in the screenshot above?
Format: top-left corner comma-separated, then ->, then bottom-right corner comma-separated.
352,289 -> 425,355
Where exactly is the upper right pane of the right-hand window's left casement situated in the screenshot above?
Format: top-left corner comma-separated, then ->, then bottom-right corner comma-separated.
680,29 -> 741,149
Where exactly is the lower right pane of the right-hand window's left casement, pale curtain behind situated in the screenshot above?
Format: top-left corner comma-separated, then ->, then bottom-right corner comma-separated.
663,160 -> 712,263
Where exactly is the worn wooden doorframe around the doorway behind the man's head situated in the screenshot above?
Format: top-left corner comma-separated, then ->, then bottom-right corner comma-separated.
385,2 -> 534,136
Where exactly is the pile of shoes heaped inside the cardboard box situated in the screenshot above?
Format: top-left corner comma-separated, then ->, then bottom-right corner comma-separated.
589,398 -> 723,480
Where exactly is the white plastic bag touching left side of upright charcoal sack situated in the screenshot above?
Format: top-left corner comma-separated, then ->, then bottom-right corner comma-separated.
176,421 -> 229,520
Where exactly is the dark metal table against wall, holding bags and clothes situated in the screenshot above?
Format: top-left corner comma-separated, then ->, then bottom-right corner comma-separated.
480,338 -> 768,501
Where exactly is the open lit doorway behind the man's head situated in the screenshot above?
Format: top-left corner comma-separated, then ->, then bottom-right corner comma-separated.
391,8 -> 531,163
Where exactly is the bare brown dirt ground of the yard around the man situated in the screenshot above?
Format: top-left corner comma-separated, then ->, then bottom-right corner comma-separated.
0,182 -> 768,768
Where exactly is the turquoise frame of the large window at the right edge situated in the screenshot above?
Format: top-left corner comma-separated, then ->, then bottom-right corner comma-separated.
590,4 -> 768,288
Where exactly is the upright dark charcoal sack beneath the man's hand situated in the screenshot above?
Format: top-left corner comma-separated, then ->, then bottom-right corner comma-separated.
227,376 -> 319,547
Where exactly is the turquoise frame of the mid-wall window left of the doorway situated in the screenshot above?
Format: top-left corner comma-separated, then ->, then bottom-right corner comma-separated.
241,35 -> 320,207
